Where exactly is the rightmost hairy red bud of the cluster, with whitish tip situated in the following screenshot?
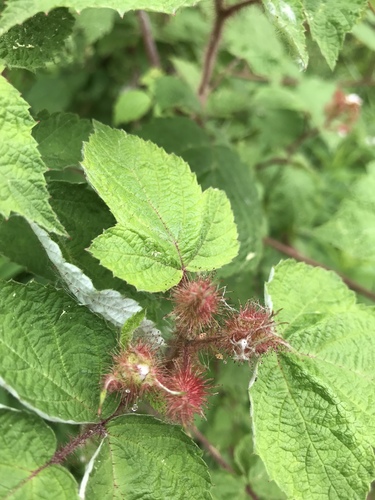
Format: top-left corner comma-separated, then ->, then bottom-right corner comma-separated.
223,303 -> 286,361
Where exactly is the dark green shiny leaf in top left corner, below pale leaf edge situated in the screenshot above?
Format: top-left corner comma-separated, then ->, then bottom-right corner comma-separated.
0,9 -> 74,71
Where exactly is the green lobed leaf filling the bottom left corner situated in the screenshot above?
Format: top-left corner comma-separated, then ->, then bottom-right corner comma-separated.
0,409 -> 78,500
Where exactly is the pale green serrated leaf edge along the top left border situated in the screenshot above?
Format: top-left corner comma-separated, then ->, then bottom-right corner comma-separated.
0,0 -> 203,34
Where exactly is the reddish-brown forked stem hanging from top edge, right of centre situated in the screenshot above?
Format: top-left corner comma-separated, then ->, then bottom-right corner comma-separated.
198,0 -> 259,105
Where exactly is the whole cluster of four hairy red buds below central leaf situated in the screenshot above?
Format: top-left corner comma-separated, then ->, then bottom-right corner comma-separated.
99,277 -> 287,426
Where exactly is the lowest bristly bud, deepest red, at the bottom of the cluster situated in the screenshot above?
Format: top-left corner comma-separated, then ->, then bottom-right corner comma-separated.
165,361 -> 209,426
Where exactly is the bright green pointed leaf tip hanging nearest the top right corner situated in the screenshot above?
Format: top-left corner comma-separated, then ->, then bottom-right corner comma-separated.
303,0 -> 367,69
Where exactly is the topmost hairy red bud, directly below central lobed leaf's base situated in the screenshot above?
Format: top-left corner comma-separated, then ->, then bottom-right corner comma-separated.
172,278 -> 223,337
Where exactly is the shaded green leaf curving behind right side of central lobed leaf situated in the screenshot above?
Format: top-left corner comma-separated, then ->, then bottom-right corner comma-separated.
182,146 -> 263,276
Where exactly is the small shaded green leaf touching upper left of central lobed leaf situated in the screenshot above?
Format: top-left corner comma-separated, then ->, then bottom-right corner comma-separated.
33,112 -> 92,169
